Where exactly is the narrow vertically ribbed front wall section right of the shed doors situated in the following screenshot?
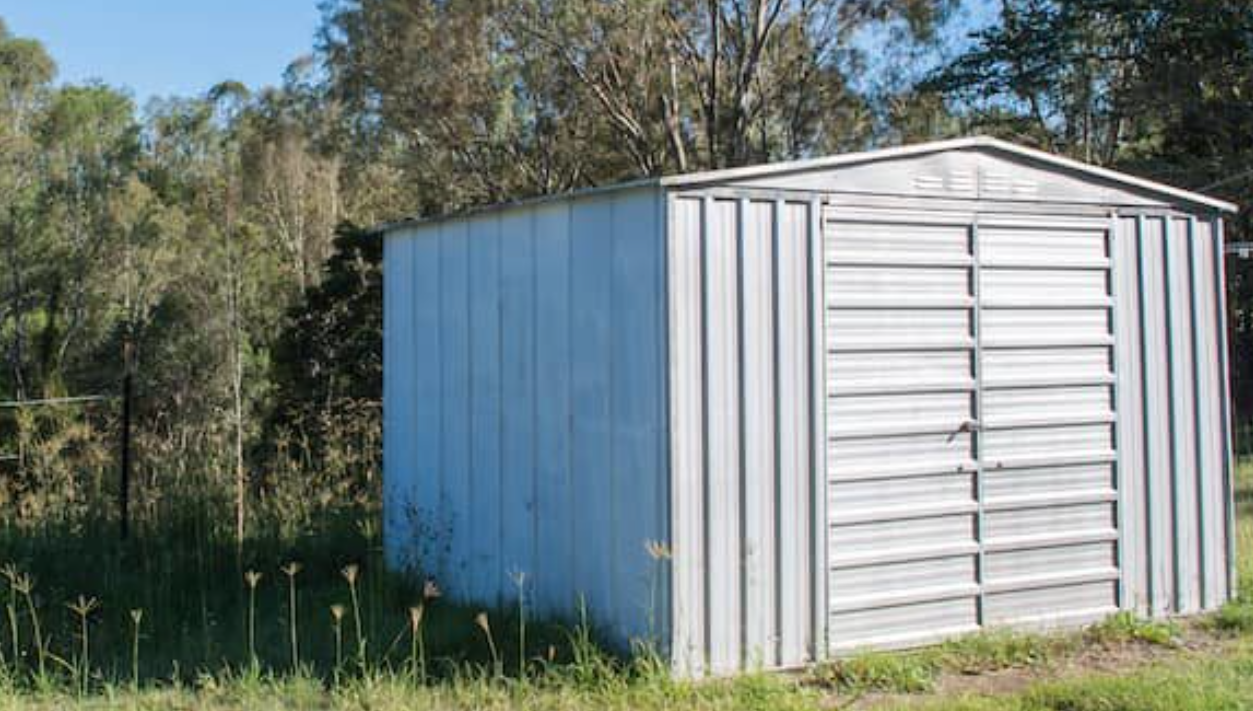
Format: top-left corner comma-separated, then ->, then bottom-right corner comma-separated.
1115,213 -> 1234,614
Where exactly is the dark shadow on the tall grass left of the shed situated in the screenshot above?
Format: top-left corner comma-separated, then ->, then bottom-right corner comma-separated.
0,514 -> 621,681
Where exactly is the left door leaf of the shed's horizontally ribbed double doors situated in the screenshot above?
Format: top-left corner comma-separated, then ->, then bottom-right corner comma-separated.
824,212 -> 979,651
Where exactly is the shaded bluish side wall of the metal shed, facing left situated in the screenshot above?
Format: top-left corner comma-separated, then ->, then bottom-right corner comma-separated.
383,188 -> 668,646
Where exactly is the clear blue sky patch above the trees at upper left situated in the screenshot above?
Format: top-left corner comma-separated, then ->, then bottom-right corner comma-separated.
0,0 -> 321,105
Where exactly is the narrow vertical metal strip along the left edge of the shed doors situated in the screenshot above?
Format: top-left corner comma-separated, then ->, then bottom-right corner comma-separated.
808,198 -> 831,661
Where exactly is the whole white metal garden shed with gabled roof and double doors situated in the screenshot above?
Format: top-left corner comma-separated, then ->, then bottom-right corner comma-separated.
383,138 -> 1234,673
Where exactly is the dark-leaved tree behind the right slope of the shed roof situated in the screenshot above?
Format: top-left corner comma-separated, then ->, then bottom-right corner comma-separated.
927,0 -> 1253,418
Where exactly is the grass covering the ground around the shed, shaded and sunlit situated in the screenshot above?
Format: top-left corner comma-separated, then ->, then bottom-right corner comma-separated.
0,460 -> 1253,711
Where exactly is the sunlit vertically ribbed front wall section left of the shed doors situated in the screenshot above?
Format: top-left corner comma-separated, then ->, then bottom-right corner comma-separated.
669,194 -> 821,673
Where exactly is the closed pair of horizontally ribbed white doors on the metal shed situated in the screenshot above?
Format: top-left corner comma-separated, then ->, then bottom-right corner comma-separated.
823,208 -> 1119,652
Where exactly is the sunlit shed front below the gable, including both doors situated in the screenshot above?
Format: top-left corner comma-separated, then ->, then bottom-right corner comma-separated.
668,186 -> 1232,673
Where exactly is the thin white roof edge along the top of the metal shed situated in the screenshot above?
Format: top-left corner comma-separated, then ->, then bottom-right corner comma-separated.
376,135 -> 1239,232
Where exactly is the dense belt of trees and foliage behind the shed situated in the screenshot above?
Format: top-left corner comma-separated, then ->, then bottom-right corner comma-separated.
0,0 -> 1253,539
